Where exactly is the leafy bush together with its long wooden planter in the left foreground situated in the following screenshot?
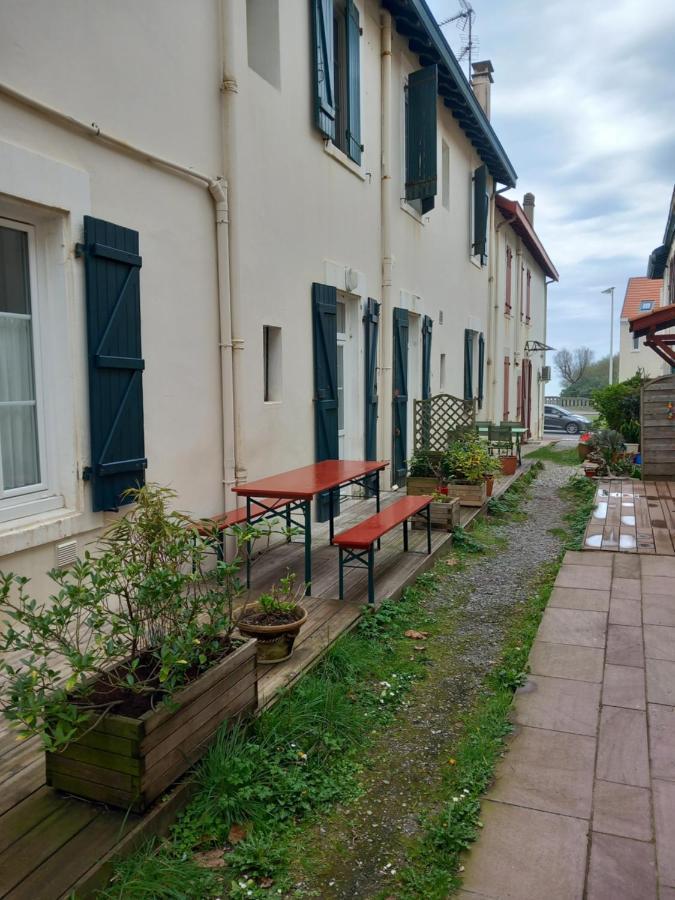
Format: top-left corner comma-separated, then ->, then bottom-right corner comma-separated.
0,485 -> 270,811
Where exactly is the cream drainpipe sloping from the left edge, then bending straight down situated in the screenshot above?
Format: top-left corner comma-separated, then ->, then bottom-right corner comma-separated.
0,83 -> 236,510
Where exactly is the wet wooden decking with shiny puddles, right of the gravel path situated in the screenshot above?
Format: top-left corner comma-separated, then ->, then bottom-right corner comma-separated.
584,478 -> 675,556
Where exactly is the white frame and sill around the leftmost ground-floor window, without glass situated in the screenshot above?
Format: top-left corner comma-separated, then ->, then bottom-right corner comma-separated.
0,216 -> 63,522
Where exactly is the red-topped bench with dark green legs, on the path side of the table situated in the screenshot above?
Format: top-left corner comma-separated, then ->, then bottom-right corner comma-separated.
333,496 -> 433,604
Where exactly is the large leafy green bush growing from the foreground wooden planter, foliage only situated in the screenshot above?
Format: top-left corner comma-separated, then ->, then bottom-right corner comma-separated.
0,485 -> 272,751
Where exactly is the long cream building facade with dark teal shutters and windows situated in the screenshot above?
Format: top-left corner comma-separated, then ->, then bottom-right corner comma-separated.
0,0 -> 546,590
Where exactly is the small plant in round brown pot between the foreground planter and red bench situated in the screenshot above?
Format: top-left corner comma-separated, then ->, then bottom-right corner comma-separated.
239,572 -> 307,663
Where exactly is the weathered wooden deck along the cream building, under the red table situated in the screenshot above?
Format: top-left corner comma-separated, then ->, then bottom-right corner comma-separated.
0,472 -> 528,900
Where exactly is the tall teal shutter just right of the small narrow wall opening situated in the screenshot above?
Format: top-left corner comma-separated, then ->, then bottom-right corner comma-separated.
312,284 -> 340,522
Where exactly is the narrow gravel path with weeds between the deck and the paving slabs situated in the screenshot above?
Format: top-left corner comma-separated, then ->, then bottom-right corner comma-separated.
296,463 -> 574,900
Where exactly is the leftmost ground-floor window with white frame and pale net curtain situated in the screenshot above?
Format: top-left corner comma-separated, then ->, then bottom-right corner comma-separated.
0,219 -> 44,505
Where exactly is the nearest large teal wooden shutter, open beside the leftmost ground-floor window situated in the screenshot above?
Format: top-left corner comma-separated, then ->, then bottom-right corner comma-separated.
78,216 -> 147,511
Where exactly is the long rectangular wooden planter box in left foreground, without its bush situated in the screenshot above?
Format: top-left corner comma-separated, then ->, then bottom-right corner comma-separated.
46,640 -> 258,812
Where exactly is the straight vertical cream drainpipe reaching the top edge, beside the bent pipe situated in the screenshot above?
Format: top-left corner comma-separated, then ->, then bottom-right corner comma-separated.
219,0 -> 248,486
